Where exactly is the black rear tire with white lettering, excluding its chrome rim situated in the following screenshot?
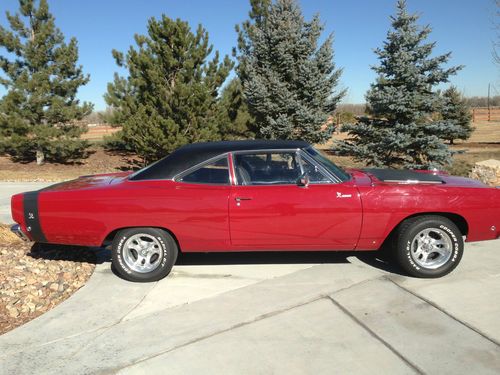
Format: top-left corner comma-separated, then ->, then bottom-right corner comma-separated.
112,228 -> 177,282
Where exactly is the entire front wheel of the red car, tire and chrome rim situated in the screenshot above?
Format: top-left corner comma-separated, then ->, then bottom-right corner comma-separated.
393,215 -> 464,278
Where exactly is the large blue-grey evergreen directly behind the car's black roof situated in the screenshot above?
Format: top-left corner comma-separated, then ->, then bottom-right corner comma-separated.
237,0 -> 344,143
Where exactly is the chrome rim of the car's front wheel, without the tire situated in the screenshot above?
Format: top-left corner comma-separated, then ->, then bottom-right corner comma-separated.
410,228 -> 453,269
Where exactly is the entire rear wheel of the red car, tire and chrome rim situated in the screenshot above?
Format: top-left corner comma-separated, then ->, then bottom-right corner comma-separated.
112,228 -> 178,282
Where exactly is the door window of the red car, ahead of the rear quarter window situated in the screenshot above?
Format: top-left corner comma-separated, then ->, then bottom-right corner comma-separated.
234,152 -> 301,185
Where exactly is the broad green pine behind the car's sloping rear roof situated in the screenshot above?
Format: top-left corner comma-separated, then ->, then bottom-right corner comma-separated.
104,15 -> 233,162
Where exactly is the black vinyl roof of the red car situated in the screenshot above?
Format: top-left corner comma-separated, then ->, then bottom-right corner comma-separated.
130,140 -> 310,180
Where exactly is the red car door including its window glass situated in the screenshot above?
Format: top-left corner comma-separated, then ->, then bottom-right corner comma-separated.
229,150 -> 361,250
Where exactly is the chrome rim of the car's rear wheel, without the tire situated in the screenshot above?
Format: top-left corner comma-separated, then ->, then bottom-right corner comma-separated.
123,233 -> 163,273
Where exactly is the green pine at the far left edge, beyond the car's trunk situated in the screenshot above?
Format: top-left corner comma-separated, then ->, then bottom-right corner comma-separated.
0,0 -> 92,164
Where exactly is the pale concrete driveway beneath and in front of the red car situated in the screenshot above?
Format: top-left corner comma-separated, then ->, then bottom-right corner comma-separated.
0,241 -> 500,374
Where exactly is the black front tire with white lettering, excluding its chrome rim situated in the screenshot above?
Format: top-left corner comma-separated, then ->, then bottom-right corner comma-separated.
398,219 -> 463,277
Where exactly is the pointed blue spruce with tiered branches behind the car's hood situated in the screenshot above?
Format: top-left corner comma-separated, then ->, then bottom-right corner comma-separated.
336,0 -> 461,168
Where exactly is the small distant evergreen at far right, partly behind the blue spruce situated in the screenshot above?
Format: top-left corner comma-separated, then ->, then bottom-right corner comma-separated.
441,86 -> 474,145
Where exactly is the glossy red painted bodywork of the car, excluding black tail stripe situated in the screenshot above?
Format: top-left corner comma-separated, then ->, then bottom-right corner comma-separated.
12,170 -> 500,252
